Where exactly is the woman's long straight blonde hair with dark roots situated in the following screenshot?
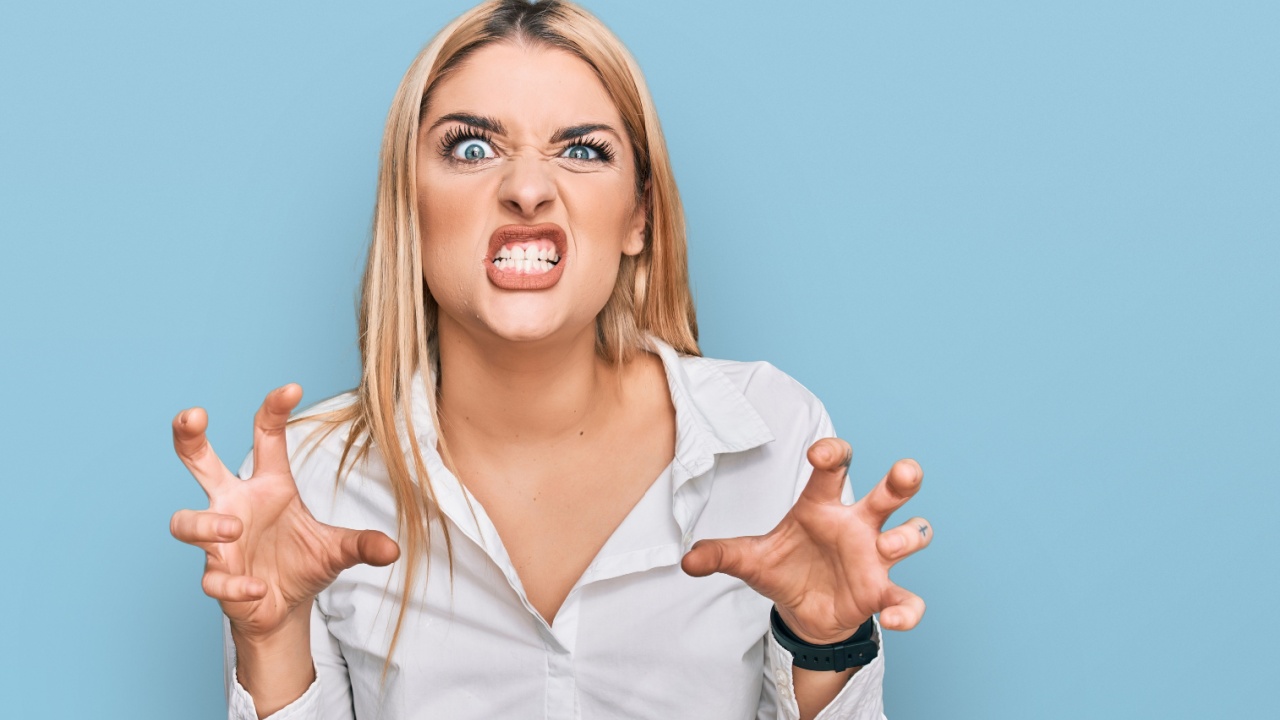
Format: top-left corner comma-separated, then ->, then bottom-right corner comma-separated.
310,0 -> 699,676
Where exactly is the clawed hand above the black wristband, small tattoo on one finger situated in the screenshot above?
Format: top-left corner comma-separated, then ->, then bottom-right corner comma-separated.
681,438 -> 933,644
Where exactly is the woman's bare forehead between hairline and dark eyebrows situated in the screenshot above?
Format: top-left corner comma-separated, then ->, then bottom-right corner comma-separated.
422,42 -> 620,133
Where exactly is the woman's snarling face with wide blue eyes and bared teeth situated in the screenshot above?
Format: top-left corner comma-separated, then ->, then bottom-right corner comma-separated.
416,42 -> 645,341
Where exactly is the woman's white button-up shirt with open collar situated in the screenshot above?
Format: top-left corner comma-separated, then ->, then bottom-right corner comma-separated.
224,340 -> 884,720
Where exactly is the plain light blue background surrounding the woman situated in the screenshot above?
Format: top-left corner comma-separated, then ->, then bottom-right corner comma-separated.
0,0 -> 1280,719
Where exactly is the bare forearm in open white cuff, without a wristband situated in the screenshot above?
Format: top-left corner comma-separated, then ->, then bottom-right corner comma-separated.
232,602 -> 316,717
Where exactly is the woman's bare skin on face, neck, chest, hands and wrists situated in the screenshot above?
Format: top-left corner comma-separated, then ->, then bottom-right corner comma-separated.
170,44 -> 933,717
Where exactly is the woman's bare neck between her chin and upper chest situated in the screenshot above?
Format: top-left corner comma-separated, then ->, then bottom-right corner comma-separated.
436,316 -> 620,447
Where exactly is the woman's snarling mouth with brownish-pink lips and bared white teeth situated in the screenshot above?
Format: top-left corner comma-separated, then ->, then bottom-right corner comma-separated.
484,223 -> 568,290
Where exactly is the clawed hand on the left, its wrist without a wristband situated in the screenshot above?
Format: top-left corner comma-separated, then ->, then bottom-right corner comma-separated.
169,384 -> 399,638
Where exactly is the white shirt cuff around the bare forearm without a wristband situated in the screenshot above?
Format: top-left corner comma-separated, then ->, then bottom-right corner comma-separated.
223,603 -> 356,720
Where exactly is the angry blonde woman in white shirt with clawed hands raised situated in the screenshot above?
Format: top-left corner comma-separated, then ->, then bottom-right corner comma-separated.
172,0 -> 932,720
